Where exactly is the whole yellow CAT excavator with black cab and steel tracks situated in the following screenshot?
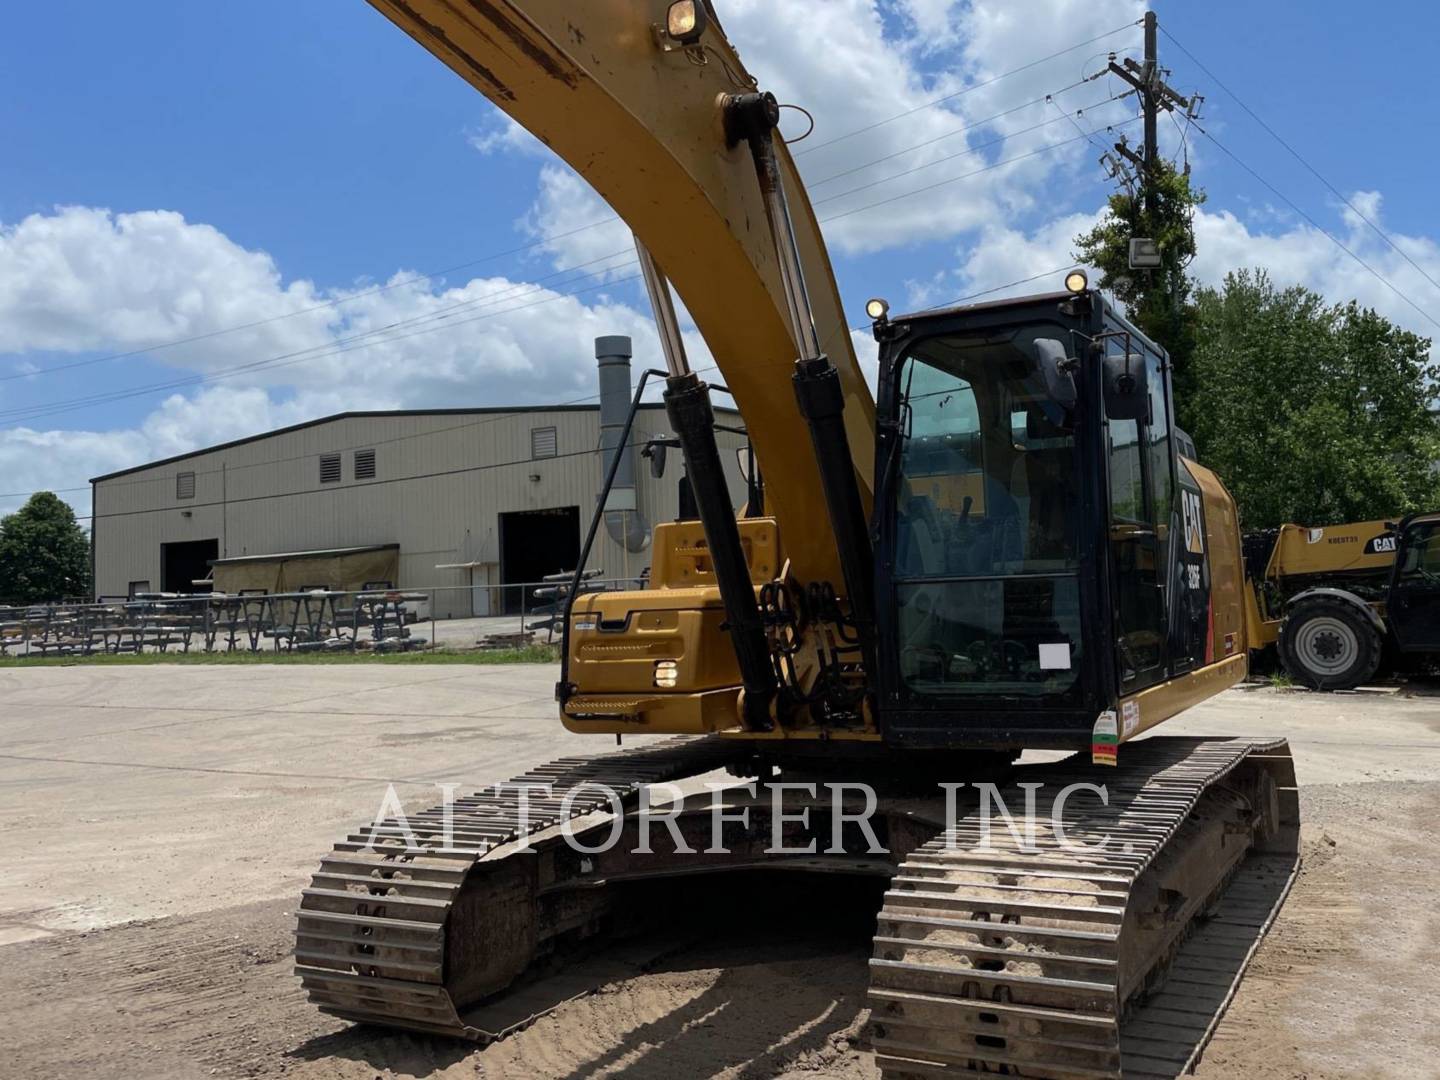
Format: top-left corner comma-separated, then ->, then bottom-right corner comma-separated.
295,0 -> 1297,1077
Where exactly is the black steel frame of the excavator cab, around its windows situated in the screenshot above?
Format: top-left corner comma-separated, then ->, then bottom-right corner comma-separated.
871,291 -> 1194,749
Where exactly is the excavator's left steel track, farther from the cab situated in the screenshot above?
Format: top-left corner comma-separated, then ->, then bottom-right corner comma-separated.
295,736 -> 744,1043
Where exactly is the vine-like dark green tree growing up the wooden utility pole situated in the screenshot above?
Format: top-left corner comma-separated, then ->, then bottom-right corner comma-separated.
1074,160 -> 1205,431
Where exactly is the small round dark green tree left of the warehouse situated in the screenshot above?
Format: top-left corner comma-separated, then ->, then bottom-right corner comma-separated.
0,491 -> 91,603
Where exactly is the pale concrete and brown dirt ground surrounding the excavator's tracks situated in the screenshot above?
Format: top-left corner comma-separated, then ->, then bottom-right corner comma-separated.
0,667 -> 1440,1080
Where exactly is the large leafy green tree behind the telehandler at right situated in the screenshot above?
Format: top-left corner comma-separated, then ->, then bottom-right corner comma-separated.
1188,271 -> 1440,528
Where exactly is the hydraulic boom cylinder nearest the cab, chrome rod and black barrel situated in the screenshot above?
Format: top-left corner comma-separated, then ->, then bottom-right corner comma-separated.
724,94 -> 876,678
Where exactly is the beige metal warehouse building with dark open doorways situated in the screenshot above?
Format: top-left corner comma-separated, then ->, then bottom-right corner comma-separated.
91,337 -> 746,618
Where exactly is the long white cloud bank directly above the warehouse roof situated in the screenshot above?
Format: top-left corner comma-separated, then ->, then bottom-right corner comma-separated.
0,207 -> 671,524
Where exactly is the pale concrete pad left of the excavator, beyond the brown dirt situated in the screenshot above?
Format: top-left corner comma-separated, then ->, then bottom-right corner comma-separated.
0,665 -> 595,939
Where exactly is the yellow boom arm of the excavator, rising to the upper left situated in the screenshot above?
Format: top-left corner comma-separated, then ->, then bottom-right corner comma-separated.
369,0 -> 874,593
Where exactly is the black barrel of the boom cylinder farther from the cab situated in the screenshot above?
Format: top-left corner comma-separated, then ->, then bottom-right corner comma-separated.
665,372 -> 776,732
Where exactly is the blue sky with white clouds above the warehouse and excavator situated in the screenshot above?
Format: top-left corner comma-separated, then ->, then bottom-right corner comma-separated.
0,0 -> 1440,524
